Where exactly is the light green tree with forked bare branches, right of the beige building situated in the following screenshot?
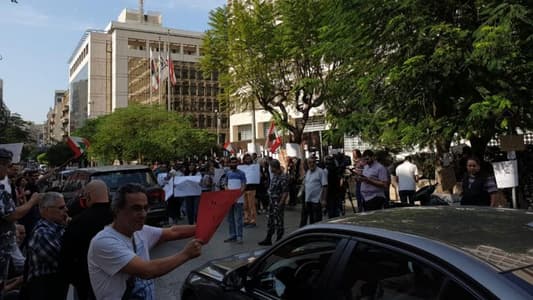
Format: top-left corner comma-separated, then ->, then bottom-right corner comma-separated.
201,0 -> 338,143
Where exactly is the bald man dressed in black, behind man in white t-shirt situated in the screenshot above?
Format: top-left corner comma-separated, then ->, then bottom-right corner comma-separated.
61,180 -> 113,300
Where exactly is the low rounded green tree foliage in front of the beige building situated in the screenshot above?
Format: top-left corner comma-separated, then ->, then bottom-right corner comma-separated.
74,105 -> 216,163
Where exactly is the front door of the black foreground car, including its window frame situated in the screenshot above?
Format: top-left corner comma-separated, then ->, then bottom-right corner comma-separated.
241,234 -> 348,300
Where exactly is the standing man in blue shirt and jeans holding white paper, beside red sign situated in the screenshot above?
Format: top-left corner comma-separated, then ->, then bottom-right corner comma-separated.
224,157 -> 246,244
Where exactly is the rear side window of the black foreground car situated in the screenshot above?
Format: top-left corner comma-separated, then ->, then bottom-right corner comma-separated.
338,242 -> 476,300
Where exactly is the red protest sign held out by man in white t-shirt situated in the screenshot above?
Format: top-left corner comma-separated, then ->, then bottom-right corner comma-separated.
195,190 -> 241,244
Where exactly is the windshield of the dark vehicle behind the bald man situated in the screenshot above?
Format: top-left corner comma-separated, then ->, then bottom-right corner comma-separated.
92,170 -> 157,192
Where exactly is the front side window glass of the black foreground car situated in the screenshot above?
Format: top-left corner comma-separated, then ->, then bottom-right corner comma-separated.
251,236 -> 341,299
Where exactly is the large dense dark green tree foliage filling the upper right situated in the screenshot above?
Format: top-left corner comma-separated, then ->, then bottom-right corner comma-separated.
323,0 -> 533,153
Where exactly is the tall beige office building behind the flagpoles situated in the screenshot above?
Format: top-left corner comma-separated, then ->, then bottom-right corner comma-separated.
69,9 -> 229,141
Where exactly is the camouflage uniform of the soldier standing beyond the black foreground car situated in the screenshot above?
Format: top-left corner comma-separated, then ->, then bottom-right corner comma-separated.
267,174 -> 289,240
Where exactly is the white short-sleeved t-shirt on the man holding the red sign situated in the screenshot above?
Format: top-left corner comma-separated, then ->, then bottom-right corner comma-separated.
87,225 -> 162,300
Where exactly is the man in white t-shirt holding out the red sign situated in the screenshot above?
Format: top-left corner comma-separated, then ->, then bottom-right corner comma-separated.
87,184 -> 201,300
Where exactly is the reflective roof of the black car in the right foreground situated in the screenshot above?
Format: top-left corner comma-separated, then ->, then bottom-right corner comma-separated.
318,206 -> 533,271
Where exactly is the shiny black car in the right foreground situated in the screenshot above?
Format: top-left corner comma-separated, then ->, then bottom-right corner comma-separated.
181,206 -> 533,300
